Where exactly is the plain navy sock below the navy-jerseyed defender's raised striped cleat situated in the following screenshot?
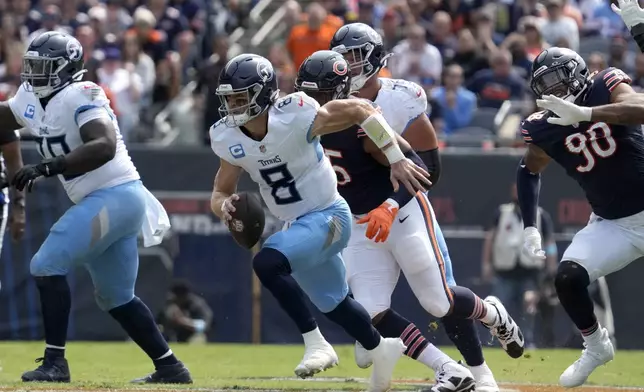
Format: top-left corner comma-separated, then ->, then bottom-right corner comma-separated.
441,314 -> 485,367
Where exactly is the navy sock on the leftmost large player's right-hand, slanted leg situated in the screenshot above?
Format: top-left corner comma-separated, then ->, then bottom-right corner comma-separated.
109,297 -> 179,368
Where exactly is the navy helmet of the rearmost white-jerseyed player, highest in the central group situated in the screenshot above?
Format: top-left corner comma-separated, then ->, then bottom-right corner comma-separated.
329,23 -> 392,91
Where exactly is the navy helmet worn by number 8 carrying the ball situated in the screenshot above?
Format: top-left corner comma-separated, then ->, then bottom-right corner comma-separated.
216,54 -> 279,127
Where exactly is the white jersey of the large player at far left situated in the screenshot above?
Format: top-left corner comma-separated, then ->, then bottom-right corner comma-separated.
9,82 -> 140,203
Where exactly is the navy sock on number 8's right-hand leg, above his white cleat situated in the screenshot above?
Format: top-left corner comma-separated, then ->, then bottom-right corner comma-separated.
324,296 -> 380,350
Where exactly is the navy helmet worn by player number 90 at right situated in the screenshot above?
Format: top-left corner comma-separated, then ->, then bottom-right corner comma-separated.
530,47 -> 590,101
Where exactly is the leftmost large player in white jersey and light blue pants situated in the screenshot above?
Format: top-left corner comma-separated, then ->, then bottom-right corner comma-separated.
0,32 -> 192,383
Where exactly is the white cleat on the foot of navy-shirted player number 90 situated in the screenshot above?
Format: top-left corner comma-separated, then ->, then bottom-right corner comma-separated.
559,327 -> 615,388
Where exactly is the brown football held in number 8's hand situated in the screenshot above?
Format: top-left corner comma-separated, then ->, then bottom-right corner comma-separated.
228,192 -> 265,249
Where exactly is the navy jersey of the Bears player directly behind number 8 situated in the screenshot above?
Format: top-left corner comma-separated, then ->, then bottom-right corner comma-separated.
321,126 -> 393,215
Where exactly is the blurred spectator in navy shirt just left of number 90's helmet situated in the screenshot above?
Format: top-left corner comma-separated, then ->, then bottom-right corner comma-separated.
466,50 -> 526,109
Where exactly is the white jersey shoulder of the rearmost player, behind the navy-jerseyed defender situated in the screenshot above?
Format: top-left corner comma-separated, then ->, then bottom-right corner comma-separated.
374,78 -> 427,134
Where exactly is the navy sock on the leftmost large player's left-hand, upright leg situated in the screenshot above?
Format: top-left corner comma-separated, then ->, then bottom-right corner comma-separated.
36,275 -> 72,358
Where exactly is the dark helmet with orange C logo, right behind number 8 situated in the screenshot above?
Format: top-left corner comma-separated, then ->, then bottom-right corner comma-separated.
295,50 -> 351,105
